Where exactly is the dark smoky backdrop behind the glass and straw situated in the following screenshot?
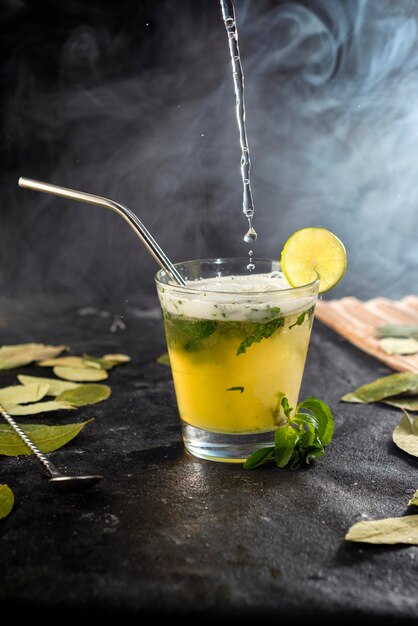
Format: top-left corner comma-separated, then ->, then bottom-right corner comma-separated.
0,0 -> 418,302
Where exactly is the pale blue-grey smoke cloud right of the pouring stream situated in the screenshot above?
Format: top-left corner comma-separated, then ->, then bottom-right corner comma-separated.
237,0 -> 418,298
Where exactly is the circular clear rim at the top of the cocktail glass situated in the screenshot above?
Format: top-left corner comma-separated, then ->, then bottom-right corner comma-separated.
154,257 -> 320,296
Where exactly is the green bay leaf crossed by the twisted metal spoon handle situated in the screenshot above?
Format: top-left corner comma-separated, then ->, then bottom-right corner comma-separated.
0,419 -> 93,456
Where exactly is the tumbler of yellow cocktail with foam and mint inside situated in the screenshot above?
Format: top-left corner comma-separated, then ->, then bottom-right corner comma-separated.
155,258 -> 319,463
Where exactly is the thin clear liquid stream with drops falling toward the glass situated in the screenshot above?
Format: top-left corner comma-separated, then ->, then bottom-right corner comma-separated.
220,0 -> 257,271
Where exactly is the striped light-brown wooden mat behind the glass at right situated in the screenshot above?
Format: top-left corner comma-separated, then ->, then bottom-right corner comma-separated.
315,295 -> 418,372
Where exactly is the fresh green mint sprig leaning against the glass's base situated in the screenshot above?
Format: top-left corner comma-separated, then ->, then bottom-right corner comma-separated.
243,392 -> 334,470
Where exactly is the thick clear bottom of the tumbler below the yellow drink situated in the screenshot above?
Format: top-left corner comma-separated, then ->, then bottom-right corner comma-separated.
182,422 -> 274,463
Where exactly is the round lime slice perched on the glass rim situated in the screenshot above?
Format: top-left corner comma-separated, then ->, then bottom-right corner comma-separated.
280,227 -> 347,293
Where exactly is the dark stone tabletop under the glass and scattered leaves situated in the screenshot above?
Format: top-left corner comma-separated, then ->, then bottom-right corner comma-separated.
0,299 -> 418,624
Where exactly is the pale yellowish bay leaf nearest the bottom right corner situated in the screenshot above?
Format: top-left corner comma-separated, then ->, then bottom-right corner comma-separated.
344,515 -> 418,545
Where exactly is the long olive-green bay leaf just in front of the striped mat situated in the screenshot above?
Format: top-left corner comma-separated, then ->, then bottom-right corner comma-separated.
341,372 -> 418,404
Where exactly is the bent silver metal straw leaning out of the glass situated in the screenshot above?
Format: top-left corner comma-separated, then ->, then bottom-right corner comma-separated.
19,177 -> 186,286
